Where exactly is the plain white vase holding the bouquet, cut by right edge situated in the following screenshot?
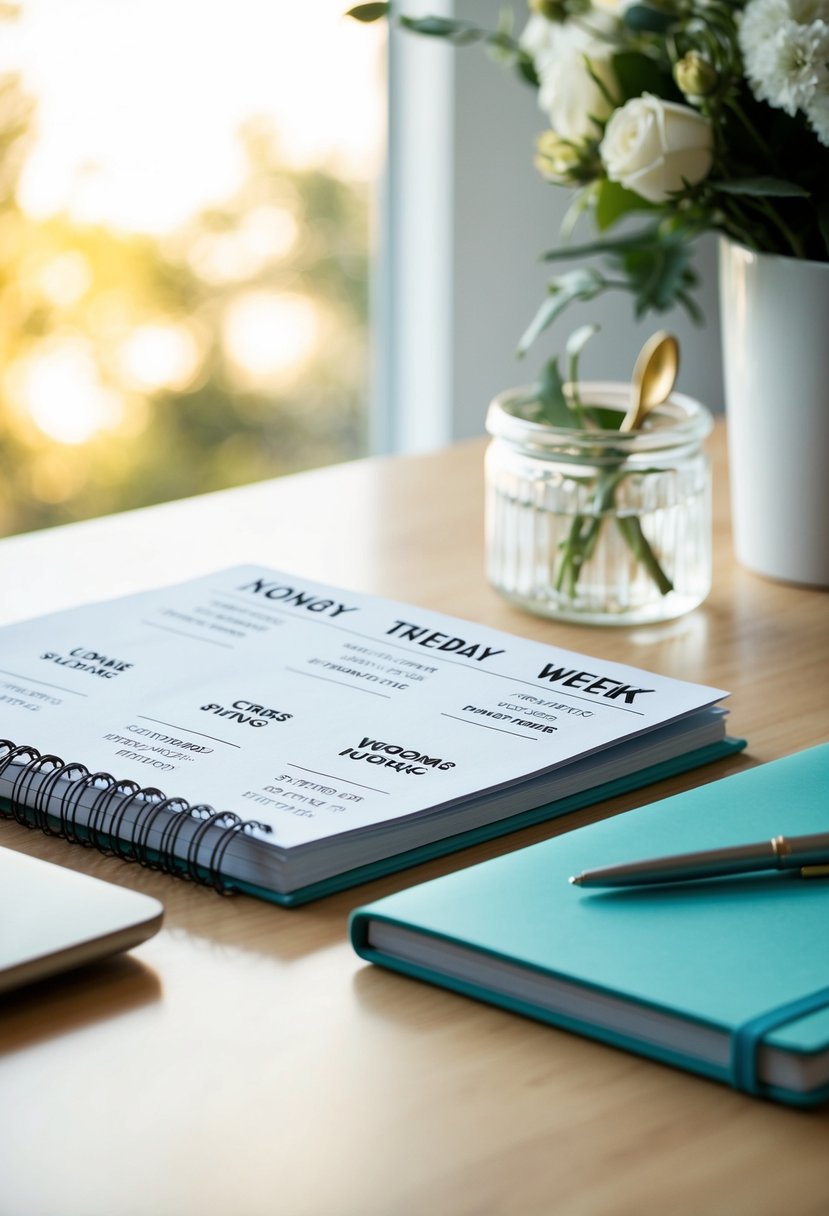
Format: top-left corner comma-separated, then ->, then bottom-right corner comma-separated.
720,241 -> 829,586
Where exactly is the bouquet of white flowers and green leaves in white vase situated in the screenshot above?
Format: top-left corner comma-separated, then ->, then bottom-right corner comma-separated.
351,0 -> 829,351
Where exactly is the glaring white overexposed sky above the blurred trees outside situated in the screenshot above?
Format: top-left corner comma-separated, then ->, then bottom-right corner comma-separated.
0,0 -> 383,233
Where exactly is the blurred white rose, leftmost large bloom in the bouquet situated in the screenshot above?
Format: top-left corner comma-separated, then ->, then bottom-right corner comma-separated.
521,11 -> 617,142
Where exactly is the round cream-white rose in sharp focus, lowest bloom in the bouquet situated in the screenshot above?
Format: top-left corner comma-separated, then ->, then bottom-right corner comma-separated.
599,94 -> 714,203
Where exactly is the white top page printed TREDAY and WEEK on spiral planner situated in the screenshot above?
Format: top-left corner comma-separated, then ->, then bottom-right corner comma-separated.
0,567 -> 726,848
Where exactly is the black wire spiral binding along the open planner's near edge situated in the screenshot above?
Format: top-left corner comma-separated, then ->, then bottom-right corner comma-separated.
0,739 -> 271,895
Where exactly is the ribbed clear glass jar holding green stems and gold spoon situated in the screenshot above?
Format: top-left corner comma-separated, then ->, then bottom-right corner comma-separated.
486,382 -> 712,625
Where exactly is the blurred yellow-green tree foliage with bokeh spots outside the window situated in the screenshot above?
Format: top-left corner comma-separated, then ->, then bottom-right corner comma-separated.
0,53 -> 368,534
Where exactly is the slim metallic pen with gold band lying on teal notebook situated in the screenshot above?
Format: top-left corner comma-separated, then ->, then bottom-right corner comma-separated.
570,832 -> 829,886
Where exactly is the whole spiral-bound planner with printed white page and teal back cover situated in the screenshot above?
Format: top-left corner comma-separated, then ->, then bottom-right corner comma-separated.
0,567 -> 741,903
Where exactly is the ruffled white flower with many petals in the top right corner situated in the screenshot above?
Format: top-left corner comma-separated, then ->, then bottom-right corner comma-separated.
738,0 -> 829,116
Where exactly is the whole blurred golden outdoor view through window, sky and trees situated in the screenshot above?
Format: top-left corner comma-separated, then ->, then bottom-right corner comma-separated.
0,0 -> 384,535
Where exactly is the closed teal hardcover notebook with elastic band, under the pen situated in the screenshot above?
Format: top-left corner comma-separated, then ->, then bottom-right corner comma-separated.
351,744 -> 829,1105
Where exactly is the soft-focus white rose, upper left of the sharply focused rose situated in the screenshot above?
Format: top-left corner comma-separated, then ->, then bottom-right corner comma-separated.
536,26 -> 617,142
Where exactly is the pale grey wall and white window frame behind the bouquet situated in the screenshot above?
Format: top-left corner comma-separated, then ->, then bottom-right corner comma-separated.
378,0 -> 722,451
